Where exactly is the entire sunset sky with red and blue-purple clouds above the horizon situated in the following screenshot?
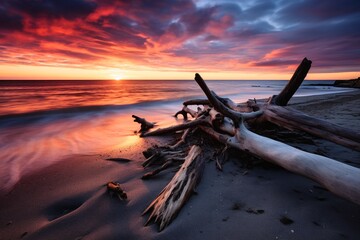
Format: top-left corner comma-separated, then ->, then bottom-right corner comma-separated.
0,0 -> 360,80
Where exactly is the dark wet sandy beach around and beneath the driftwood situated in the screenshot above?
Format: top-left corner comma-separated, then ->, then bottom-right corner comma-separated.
0,90 -> 360,240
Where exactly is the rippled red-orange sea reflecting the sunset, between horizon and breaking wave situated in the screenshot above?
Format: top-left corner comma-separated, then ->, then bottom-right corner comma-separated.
0,80 -> 187,116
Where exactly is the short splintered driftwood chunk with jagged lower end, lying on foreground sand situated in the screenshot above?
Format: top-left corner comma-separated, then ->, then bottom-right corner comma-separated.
143,146 -> 204,231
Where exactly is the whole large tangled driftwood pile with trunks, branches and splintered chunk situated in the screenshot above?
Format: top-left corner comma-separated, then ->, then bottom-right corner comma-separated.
133,58 -> 360,230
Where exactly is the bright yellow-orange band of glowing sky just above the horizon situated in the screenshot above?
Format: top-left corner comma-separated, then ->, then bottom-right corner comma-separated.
0,65 -> 360,81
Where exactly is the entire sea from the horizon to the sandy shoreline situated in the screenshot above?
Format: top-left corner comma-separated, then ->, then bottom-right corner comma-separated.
0,81 -> 350,191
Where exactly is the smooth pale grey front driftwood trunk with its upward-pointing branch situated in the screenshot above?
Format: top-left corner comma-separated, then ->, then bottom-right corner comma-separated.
195,74 -> 360,204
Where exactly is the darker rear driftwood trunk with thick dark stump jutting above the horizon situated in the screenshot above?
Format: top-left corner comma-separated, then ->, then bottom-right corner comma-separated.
240,58 -> 360,151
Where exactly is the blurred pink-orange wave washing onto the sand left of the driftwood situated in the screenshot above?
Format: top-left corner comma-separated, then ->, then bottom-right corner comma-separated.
0,98 -> 186,192
